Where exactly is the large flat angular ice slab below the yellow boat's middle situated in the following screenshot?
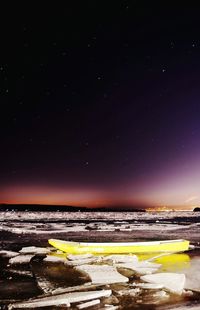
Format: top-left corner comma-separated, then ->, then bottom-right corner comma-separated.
75,265 -> 128,284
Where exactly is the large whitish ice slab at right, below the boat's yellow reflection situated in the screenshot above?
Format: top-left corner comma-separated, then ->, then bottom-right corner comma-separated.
140,273 -> 185,294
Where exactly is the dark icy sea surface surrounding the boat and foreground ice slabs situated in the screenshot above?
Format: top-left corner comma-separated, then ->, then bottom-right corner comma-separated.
0,212 -> 200,310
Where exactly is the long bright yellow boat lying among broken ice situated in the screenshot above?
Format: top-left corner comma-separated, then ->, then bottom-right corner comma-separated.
49,239 -> 189,254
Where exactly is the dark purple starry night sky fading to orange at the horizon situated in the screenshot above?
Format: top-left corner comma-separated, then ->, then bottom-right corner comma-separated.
0,0 -> 200,209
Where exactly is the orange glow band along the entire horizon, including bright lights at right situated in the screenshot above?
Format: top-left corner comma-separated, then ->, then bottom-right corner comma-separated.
0,185 -> 199,212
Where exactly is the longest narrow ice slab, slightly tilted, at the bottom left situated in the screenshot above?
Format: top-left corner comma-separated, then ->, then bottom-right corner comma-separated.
8,290 -> 112,310
